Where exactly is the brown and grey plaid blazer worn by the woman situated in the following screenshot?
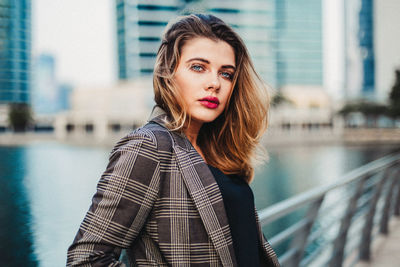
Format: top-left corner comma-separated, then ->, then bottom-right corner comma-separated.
67,106 -> 279,266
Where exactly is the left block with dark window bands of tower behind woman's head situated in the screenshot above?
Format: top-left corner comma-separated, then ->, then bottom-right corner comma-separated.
116,0 -> 274,84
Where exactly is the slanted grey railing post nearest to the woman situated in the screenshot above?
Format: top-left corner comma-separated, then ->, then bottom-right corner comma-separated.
290,195 -> 325,266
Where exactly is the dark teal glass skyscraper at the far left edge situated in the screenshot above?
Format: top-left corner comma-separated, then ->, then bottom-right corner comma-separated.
0,0 -> 31,104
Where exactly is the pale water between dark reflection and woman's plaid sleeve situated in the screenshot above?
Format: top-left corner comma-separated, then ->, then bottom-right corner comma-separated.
26,144 -> 108,267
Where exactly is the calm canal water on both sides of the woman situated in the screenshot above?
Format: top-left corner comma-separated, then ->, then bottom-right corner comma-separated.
0,143 -> 400,267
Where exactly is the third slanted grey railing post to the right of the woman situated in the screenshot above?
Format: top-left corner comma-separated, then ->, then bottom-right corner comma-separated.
359,168 -> 391,261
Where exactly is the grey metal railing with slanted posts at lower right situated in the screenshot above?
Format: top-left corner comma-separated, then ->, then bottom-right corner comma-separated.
259,153 -> 400,267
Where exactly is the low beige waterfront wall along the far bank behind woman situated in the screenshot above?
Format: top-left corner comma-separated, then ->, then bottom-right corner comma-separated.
0,128 -> 400,147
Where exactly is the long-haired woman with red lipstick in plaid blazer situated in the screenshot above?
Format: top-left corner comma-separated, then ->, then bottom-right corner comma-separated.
67,15 -> 279,266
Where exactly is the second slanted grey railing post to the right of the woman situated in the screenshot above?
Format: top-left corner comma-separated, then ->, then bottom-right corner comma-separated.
329,176 -> 369,267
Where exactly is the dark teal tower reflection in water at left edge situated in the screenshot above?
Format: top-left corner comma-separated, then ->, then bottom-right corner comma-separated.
0,147 -> 38,266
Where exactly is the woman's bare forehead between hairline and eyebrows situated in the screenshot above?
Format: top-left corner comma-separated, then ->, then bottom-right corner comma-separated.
181,37 -> 235,66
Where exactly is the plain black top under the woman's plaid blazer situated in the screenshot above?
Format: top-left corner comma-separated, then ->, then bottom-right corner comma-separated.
208,165 -> 260,267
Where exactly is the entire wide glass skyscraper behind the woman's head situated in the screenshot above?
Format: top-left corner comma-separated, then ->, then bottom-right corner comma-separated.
116,0 -> 323,88
